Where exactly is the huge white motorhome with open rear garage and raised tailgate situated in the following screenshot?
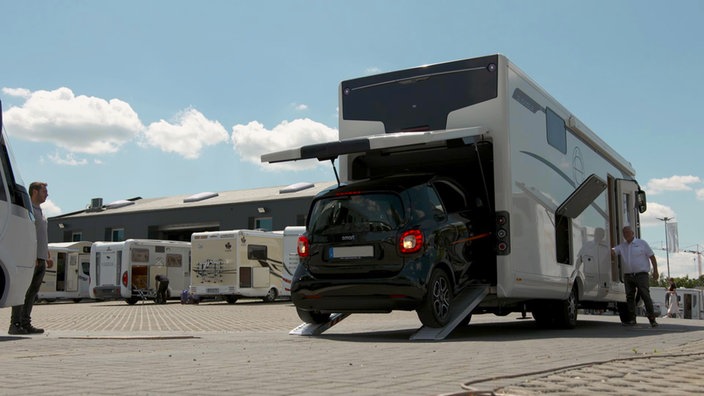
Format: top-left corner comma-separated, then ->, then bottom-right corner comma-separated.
262,54 -> 646,334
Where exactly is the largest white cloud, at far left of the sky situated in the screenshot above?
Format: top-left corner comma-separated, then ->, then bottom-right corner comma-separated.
3,87 -> 143,154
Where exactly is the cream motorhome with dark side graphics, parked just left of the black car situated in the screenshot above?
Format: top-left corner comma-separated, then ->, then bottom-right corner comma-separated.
190,227 -> 305,304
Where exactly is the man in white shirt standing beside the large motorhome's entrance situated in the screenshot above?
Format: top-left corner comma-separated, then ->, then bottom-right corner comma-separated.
613,226 -> 659,327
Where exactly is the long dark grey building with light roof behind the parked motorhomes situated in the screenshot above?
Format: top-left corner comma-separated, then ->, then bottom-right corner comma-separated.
48,182 -> 336,242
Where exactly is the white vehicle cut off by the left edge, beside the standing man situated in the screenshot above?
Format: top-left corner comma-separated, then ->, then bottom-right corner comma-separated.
0,100 -> 37,307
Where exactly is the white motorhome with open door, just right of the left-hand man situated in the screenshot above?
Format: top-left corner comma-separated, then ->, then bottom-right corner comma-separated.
37,241 -> 93,302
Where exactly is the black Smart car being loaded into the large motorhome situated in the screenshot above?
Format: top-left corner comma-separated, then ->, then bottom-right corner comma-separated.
291,174 -> 493,327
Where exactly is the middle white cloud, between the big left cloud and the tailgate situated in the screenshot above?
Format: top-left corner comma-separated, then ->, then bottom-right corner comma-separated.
144,108 -> 228,159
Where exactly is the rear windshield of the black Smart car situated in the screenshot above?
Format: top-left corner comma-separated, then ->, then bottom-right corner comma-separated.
308,193 -> 403,235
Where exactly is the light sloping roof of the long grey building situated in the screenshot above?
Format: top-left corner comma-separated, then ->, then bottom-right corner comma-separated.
54,181 -> 336,218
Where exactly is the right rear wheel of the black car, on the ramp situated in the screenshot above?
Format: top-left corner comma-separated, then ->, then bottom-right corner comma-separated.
416,268 -> 452,327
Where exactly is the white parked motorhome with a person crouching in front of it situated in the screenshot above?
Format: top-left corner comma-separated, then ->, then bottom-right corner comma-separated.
90,239 -> 191,305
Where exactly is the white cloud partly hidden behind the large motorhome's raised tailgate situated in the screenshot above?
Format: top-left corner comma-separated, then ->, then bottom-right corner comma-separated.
232,118 -> 338,170
